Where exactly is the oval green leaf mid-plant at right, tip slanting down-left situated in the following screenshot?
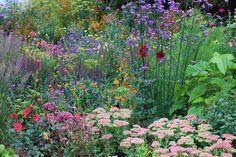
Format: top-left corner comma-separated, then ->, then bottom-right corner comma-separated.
188,84 -> 207,102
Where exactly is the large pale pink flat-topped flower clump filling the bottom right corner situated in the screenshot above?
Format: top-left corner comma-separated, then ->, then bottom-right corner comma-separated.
120,115 -> 236,157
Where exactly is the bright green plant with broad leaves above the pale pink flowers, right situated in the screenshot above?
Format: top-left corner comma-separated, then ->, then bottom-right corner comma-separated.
170,53 -> 236,117
